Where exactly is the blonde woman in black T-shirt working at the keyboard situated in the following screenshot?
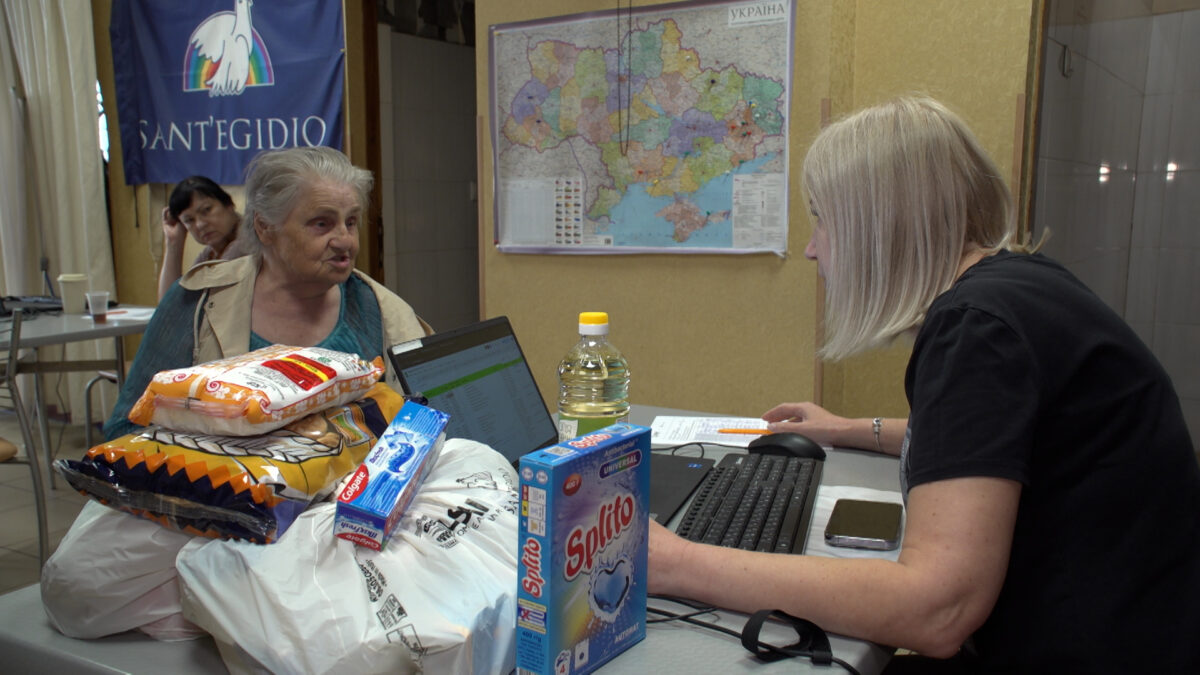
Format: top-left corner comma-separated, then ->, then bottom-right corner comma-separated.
649,97 -> 1200,673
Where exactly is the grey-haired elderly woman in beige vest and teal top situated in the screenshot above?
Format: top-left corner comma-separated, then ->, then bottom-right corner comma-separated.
104,148 -> 431,440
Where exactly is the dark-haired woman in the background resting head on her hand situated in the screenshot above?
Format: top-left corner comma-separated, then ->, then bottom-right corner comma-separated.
158,175 -> 248,300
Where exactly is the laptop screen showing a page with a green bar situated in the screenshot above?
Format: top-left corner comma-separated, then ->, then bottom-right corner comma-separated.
388,316 -> 558,464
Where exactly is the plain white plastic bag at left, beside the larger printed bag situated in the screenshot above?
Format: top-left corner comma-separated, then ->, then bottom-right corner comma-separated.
42,501 -> 204,640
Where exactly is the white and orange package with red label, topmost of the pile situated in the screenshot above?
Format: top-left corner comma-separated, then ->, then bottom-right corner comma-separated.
130,345 -> 384,436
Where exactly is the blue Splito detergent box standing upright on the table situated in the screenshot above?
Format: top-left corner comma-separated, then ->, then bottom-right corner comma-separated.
517,424 -> 650,675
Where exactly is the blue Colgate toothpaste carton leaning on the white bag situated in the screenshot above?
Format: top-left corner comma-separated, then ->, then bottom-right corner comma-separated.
334,401 -> 450,551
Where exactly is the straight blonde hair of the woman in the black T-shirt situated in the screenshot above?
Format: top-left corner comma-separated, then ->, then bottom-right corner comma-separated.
804,96 -> 1015,359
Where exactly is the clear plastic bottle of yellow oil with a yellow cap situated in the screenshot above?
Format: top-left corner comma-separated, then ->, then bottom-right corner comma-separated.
558,312 -> 629,441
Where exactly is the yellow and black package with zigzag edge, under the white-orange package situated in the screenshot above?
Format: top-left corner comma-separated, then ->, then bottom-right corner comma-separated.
55,383 -> 404,544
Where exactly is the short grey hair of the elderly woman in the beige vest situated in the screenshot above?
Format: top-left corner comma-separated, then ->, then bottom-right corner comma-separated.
238,145 -> 374,253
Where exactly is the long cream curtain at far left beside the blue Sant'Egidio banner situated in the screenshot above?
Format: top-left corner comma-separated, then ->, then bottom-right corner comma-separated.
0,0 -> 115,427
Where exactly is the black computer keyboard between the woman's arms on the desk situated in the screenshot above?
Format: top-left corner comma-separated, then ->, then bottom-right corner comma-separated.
676,453 -> 822,554
